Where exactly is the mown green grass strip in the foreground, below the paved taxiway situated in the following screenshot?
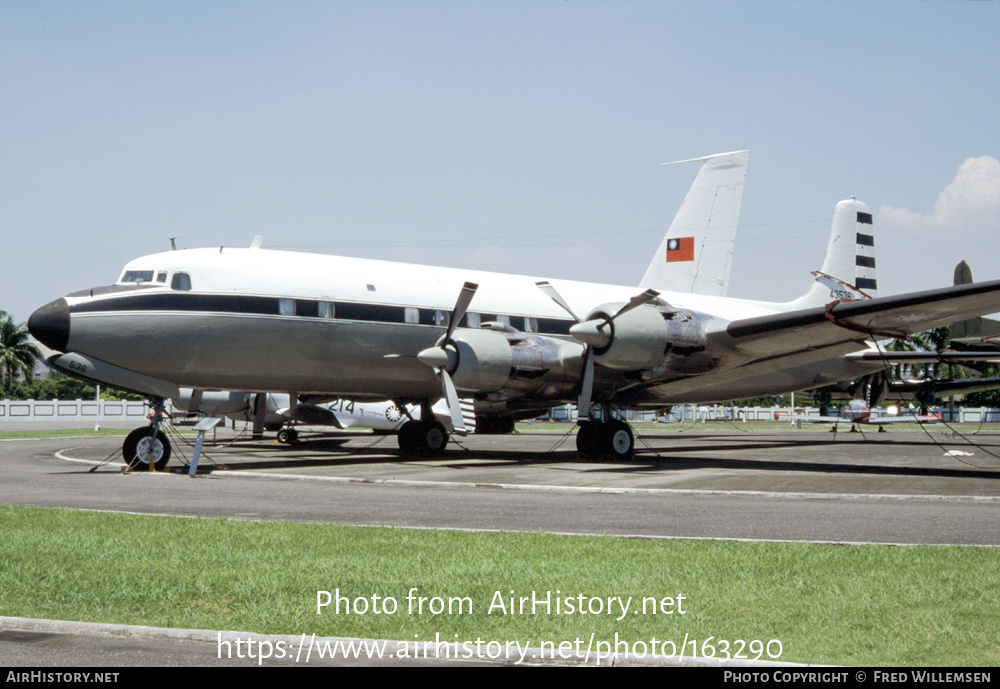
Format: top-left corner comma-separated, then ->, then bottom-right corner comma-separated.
0,506 -> 1000,666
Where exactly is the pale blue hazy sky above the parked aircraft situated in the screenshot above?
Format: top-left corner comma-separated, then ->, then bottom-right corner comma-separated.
0,0 -> 1000,321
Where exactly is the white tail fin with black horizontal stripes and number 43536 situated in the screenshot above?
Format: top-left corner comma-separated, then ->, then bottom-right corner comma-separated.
792,198 -> 878,308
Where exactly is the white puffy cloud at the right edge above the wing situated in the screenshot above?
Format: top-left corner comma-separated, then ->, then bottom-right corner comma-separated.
878,156 -> 1000,232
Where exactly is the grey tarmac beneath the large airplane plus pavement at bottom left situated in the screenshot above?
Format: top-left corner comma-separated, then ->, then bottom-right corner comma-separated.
0,424 -> 1000,666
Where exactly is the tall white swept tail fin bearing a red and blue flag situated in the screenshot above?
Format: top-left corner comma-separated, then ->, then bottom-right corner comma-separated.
639,151 -> 750,296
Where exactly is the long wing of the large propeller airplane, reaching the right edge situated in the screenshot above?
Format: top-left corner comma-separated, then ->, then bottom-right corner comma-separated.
726,280 -> 1000,358
